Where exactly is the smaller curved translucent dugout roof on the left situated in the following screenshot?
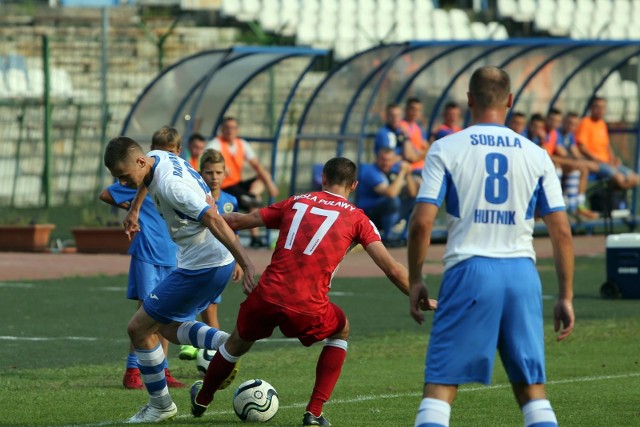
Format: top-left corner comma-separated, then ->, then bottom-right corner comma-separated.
121,46 -> 326,160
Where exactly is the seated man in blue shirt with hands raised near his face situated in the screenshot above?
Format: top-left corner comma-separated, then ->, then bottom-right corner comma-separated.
356,148 -> 418,246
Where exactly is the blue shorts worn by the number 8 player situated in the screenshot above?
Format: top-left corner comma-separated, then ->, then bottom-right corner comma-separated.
425,257 -> 545,385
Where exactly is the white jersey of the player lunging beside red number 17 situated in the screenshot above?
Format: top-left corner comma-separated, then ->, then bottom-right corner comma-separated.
146,150 -> 233,270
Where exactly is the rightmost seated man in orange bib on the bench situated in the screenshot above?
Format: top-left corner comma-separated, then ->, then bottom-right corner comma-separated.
576,97 -> 639,190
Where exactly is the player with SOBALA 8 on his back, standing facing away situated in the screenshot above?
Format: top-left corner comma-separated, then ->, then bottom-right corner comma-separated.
408,67 -> 574,427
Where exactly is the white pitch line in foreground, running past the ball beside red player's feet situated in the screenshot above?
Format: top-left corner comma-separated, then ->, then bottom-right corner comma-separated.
65,372 -> 640,427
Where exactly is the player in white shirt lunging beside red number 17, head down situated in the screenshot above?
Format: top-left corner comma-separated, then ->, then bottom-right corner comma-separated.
104,137 -> 256,423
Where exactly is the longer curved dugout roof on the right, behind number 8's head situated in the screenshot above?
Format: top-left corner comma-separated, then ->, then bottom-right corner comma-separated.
291,39 -> 640,224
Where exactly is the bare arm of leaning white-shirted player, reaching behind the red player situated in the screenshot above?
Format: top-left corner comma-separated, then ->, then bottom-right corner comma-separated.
200,209 -> 256,295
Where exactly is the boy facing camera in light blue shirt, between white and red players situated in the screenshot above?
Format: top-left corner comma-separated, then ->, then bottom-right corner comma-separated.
179,148 -> 242,360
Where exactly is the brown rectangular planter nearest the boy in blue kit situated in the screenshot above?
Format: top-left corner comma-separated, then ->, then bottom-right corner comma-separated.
71,227 -> 131,254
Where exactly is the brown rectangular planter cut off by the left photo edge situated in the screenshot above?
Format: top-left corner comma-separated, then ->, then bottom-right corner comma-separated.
0,224 -> 56,252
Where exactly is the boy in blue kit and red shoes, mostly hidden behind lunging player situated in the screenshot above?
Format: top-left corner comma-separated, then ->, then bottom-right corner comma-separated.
100,126 -> 186,389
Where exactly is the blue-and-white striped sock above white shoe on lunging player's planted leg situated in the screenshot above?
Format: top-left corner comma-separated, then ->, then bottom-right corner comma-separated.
136,344 -> 171,408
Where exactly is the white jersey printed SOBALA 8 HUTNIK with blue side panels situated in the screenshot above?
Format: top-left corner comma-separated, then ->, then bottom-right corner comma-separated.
417,124 -> 564,269
